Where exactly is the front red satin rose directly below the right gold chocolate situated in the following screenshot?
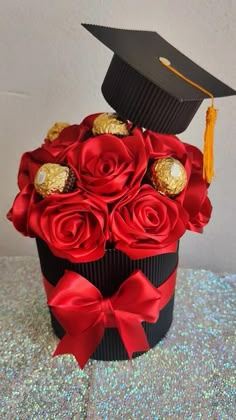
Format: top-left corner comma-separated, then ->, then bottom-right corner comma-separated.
110,185 -> 188,259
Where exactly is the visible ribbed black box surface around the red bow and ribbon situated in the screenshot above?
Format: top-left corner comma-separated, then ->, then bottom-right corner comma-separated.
36,238 -> 178,360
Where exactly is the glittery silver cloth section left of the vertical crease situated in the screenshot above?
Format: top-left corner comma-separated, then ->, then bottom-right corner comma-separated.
0,257 -> 92,420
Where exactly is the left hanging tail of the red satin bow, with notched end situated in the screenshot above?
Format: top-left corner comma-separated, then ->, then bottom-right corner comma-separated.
53,322 -> 104,369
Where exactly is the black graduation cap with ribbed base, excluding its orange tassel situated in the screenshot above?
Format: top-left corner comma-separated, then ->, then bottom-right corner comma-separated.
82,24 -> 236,134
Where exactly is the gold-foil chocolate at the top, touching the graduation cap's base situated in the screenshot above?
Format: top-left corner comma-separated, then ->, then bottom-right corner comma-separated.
92,113 -> 129,136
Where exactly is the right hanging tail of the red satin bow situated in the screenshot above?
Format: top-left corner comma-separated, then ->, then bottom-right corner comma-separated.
116,311 -> 150,359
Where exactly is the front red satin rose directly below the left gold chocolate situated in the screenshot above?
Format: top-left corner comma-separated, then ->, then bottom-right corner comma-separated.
29,192 -> 108,263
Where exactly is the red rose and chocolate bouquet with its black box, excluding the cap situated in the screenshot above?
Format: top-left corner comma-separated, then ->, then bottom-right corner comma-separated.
8,114 -> 212,366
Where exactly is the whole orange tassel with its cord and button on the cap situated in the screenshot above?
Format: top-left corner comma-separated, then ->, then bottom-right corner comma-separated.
159,57 -> 217,184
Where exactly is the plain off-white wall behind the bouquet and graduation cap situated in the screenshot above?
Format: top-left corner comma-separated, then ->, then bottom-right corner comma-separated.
0,0 -> 236,272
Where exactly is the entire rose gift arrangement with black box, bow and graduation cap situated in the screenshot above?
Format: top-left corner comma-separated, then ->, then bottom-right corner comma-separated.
8,25 -> 235,368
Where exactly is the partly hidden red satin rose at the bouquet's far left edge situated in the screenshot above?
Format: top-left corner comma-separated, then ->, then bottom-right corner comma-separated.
7,184 -> 40,238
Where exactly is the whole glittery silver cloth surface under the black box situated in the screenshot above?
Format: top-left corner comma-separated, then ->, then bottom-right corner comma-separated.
0,257 -> 236,420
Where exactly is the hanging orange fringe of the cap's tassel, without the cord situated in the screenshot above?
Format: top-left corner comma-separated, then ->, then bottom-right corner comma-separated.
203,104 -> 217,184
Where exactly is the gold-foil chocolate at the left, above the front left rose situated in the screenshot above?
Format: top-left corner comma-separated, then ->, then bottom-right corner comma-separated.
34,163 -> 76,198
